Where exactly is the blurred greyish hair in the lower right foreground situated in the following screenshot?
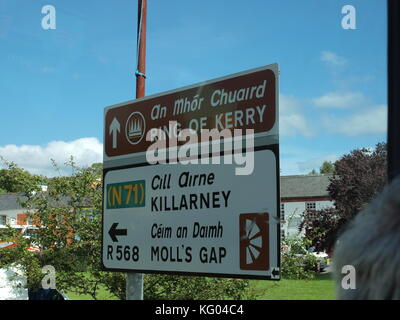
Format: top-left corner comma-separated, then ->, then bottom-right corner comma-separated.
333,176 -> 400,300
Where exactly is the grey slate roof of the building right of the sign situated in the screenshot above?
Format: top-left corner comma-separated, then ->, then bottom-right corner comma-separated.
281,174 -> 333,198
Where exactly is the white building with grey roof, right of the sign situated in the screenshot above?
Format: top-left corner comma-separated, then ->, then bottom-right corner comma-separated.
280,174 -> 334,238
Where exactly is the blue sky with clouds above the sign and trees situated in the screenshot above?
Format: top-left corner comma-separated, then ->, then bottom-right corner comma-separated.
0,0 -> 387,175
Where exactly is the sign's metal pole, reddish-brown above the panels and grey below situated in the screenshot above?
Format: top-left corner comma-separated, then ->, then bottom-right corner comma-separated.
126,0 -> 147,300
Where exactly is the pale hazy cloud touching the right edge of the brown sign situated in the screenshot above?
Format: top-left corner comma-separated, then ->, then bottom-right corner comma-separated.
279,94 -> 313,137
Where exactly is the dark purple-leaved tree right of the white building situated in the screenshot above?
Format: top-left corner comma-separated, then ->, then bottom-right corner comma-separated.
300,143 -> 387,251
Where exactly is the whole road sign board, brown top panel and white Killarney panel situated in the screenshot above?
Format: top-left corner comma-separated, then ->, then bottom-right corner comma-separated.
102,64 -> 280,280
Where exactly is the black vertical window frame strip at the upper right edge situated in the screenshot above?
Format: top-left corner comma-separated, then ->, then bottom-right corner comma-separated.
387,0 -> 400,182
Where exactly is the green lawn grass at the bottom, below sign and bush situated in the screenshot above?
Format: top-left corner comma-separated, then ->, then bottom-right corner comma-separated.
67,274 -> 335,300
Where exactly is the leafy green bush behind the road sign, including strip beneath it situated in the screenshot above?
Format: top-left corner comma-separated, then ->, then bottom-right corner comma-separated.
0,159 -> 254,299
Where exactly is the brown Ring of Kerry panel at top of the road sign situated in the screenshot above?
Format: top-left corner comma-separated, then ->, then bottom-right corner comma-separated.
104,64 -> 278,158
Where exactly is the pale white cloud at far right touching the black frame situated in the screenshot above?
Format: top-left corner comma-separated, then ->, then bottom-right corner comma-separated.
324,105 -> 387,136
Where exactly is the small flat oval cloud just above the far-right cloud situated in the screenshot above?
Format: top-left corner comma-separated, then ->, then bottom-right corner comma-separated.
313,92 -> 368,109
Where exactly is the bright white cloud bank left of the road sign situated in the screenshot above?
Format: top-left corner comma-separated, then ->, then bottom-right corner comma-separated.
0,138 -> 103,176
